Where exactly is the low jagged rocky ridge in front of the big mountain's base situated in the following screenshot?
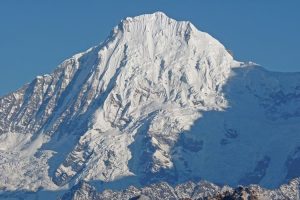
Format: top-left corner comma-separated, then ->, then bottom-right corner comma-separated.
61,179 -> 300,200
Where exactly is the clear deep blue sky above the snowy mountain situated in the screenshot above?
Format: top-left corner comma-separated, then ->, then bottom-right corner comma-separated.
0,0 -> 300,96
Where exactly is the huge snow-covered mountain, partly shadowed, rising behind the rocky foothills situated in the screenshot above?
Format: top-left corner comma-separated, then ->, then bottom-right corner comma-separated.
0,12 -> 300,198
